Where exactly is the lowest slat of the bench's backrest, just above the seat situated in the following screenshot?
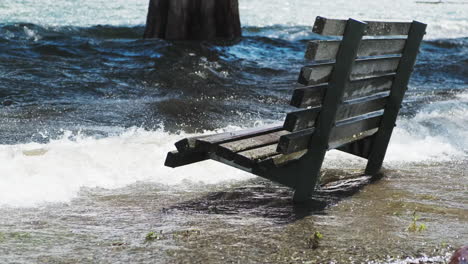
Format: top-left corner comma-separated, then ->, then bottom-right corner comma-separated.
278,112 -> 382,154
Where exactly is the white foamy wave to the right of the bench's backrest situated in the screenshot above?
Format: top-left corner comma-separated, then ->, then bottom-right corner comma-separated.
386,97 -> 468,162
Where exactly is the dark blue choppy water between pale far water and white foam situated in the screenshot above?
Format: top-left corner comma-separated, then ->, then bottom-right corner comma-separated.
0,24 -> 468,144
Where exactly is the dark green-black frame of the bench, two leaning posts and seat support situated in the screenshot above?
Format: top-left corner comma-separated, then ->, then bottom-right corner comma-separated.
166,17 -> 426,202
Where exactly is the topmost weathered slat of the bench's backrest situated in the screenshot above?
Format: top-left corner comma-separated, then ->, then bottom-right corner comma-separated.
312,16 -> 411,36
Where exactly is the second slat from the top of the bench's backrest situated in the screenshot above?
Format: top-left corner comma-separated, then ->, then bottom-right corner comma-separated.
305,38 -> 406,61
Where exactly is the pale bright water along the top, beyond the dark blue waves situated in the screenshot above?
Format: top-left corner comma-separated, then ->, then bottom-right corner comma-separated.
0,0 -> 468,39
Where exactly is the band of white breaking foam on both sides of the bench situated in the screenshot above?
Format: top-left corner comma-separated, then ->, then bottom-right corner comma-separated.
0,94 -> 468,206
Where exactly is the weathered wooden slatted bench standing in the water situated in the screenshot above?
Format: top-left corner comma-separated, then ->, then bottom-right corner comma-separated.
165,17 -> 426,202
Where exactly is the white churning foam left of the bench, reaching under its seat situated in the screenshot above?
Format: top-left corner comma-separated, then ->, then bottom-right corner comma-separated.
0,128 -> 252,206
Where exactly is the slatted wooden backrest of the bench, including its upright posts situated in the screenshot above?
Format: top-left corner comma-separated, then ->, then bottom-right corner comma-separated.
278,17 -> 426,157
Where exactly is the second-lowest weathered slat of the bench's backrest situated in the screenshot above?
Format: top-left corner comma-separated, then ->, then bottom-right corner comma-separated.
284,92 -> 389,132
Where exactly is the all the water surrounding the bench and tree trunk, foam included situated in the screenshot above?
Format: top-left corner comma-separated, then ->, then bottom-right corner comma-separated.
0,0 -> 468,263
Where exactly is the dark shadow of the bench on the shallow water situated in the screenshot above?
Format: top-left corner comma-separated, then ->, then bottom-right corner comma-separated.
164,170 -> 384,224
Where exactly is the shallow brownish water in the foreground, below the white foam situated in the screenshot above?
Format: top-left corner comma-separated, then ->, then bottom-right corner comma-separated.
0,163 -> 468,263
